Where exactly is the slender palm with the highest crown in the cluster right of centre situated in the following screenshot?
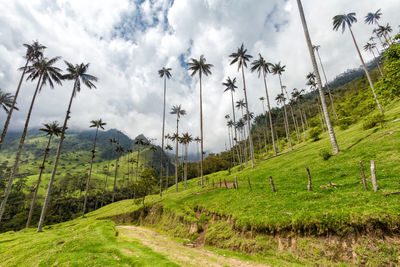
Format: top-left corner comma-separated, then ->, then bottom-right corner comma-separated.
229,44 -> 254,168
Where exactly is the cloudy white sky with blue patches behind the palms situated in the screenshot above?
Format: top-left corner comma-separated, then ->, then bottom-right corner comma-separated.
0,0 -> 400,152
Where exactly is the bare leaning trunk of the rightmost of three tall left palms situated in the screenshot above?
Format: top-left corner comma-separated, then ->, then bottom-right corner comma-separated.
37,80 -> 77,232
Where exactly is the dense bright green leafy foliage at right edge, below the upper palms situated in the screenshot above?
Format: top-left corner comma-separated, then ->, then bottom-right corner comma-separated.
376,44 -> 400,103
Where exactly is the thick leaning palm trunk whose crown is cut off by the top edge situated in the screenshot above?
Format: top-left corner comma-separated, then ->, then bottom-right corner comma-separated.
297,0 -> 339,154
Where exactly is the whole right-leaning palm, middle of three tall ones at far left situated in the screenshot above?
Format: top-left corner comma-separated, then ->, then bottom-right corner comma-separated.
0,57 -> 62,221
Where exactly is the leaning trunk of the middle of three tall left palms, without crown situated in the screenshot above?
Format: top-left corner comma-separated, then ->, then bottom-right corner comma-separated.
0,74 -> 43,221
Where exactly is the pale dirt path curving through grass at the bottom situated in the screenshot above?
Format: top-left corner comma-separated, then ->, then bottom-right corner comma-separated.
116,225 -> 266,267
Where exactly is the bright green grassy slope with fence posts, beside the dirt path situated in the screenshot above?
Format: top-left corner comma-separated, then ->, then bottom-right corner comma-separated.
0,103 -> 400,265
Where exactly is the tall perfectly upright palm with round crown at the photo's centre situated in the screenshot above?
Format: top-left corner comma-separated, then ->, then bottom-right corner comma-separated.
188,55 -> 213,184
